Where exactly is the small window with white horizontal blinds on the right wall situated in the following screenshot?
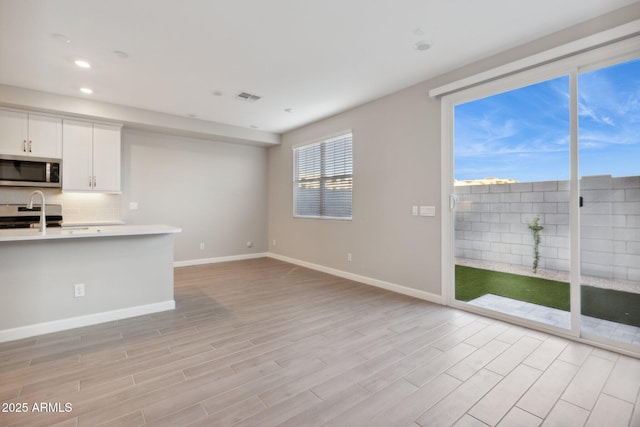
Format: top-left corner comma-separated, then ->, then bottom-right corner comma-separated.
293,133 -> 353,219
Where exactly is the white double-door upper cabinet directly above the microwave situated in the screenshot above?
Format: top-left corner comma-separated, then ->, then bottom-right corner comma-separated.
0,110 -> 62,159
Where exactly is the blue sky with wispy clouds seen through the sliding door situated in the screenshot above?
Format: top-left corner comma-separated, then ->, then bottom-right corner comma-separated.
454,60 -> 640,182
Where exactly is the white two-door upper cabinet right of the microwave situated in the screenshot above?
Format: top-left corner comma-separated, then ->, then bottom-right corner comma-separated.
62,120 -> 121,193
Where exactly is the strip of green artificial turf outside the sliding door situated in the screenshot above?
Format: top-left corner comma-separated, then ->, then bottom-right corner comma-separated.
456,265 -> 640,327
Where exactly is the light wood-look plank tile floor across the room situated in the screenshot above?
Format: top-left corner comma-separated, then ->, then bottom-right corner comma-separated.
0,258 -> 640,427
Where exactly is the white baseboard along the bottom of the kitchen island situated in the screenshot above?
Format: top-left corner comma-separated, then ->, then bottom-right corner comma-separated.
0,300 -> 176,343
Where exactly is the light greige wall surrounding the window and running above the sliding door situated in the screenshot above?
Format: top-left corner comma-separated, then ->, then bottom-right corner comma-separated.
269,4 -> 640,294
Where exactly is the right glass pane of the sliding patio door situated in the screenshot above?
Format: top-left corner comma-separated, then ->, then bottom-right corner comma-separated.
578,60 -> 640,347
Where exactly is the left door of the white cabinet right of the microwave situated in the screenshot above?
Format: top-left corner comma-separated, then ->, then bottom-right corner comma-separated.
62,120 -> 93,191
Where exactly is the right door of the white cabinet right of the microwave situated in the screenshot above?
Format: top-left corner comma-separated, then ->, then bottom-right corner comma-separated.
93,124 -> 120,192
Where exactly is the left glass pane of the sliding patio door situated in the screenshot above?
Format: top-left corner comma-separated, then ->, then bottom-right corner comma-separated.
453,75 -> 571,329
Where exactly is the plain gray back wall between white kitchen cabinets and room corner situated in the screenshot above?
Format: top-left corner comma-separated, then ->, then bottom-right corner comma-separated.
121,129 -> 267,261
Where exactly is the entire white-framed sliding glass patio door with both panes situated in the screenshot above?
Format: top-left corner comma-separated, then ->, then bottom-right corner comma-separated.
443,46 -> 640,354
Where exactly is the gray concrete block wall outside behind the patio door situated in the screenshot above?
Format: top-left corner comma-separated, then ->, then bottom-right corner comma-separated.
455,175 -> 640,282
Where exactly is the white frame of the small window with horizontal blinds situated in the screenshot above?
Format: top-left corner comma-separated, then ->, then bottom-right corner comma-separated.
291,129 -> 354,221
